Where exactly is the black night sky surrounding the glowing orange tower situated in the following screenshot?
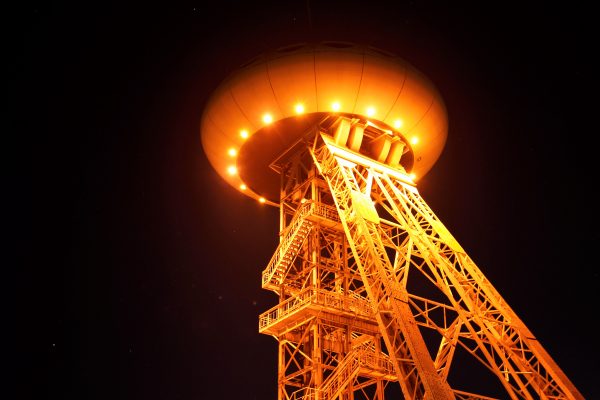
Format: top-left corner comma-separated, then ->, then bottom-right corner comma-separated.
17,0 -> 600,400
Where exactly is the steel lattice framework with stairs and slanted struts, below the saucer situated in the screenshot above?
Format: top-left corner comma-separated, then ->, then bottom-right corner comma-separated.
259,117 -> 583,400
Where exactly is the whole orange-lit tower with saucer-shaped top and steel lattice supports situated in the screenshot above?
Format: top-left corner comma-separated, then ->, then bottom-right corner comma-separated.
201,43 -> 583,400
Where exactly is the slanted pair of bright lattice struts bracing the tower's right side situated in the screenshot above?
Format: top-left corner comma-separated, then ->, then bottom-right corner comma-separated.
312,126 -> 582,399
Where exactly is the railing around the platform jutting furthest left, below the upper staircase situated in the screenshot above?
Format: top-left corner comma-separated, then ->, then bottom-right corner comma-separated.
258,288 -> 373,331
